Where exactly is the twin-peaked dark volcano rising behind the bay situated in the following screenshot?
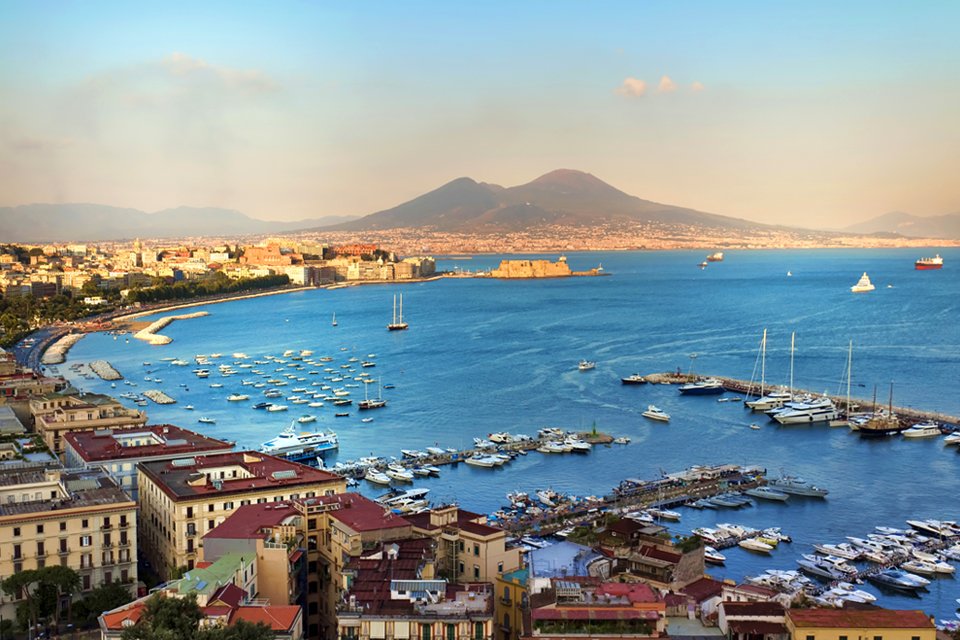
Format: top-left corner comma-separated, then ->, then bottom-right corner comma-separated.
322,169 -> 766,232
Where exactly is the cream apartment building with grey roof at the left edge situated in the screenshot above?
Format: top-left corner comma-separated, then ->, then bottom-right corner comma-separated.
0,468 -> 137,620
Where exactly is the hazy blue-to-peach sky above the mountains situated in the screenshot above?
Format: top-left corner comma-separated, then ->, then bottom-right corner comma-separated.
0,0 -> 960,228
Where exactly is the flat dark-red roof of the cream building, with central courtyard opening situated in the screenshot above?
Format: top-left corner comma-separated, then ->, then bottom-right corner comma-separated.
139,451 -> 341,500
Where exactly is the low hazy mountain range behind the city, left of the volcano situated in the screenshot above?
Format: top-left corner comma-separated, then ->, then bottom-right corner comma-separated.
0,204 -> 352,242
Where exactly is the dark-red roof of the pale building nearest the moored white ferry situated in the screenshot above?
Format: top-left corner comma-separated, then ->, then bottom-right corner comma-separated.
63,424 -> 233,462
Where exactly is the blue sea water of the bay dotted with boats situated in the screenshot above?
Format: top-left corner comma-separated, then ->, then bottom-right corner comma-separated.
60,249 -> 960,619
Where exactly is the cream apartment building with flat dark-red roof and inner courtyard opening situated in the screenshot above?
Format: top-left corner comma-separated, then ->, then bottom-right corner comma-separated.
137,451 -> 346,579
